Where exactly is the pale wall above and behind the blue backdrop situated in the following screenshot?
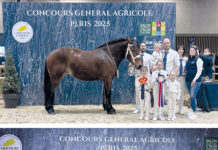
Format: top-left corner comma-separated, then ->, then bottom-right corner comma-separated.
0,0 -> 218,34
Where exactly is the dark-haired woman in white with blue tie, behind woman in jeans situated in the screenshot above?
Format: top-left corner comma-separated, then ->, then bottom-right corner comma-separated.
177,45 -> 188,114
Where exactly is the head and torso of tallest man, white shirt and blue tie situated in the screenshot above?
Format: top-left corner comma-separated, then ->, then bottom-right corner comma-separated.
163,38 -> 180,74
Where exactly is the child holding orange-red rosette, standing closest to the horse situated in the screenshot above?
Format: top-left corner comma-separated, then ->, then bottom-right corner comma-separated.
136,67 -> 151,120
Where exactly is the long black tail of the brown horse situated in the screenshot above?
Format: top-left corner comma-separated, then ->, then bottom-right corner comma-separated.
44,63 -> 51,111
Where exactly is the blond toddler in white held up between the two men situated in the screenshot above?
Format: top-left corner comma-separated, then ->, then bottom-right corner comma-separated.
152,43 -> 163,71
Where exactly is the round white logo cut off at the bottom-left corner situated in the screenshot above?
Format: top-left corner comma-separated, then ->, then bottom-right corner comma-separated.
0,134 -> 22,150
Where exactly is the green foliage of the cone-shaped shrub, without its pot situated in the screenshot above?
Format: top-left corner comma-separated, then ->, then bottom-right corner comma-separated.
2,49 -> 20,94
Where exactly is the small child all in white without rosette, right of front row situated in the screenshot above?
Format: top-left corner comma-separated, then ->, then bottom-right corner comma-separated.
166,71 -> 181,121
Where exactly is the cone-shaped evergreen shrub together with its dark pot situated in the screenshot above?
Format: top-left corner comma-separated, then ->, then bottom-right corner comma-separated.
2,49 -> 20,108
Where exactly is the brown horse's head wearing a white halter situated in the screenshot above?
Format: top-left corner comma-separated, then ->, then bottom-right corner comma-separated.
126,38 -> 142,69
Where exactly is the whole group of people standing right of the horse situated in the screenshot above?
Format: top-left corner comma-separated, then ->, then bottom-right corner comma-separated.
128,38 -> 213,121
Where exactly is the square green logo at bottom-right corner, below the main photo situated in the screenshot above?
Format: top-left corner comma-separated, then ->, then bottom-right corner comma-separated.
204,137 -> 218,150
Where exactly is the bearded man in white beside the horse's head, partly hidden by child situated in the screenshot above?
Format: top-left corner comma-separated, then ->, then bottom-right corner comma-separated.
129,43 -> 153,113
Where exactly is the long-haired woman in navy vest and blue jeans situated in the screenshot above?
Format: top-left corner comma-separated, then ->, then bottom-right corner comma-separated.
185,46 -> 203,119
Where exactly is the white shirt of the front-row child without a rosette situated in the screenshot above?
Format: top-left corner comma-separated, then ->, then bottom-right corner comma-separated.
166,80 -> 181,99
